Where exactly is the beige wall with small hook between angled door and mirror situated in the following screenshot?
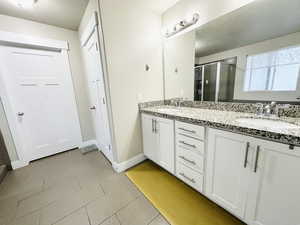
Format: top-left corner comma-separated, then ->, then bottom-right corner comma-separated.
100,0 -> 163,162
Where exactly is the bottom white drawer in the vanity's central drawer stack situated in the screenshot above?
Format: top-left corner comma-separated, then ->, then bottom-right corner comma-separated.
176,163 -> 203,192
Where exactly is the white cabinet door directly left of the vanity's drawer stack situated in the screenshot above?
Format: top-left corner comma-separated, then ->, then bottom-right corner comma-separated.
156,118 -> 175,174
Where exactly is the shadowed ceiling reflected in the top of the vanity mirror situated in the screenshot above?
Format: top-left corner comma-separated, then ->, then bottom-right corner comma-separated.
196,0 -> 300,57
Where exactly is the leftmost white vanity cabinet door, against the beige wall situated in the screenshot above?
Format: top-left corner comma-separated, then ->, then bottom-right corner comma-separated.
142,114 -> 158,162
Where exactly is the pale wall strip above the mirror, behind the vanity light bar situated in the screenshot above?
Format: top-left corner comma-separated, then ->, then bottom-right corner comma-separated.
163,0 -> 253,34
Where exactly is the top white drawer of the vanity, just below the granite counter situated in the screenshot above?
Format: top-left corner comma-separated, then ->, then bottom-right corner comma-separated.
175,121 -> 204,140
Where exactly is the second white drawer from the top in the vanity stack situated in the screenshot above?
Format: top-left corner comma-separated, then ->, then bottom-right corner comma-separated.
176,134 -> 204,155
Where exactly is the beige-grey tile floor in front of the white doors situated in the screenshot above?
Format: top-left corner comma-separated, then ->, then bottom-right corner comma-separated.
0,150 -> 168,225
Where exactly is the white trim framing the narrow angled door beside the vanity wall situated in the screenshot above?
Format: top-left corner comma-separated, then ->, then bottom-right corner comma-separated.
80,11 -> 119,164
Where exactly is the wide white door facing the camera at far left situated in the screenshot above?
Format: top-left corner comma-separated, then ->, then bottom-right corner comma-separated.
0,46 -> 81,161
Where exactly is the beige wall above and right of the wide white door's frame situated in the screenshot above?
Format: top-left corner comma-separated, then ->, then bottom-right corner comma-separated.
0,15 -> 93,160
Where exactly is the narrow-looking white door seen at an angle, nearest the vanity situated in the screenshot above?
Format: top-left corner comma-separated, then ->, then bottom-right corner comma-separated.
84,31 -> 112,161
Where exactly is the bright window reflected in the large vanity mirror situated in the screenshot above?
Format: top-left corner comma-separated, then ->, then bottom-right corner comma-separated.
244,46 -> 300,91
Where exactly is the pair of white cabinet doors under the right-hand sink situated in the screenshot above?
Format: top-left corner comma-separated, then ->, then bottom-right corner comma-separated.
205,129 -> 300,225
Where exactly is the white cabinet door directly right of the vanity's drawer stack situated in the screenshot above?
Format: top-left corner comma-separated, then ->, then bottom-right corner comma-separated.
206,129 -> 252,218
